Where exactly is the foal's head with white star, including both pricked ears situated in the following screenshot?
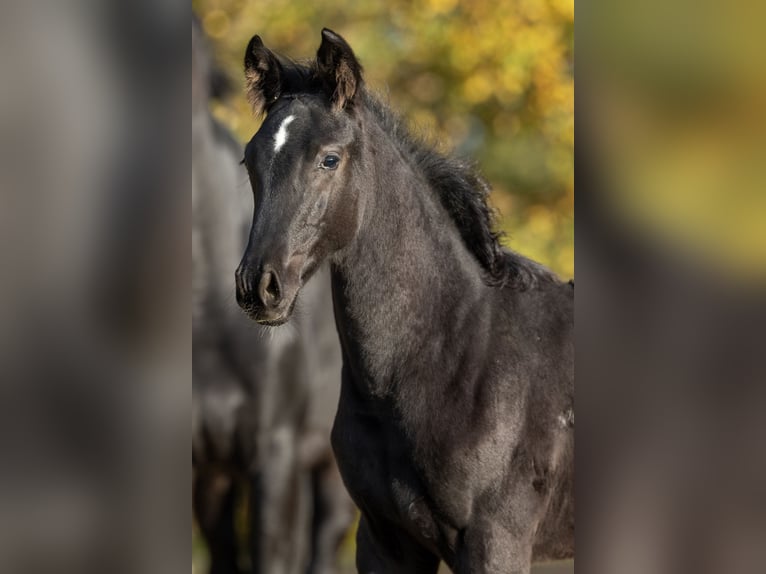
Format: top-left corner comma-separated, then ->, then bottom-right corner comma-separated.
236,30 -> 363,325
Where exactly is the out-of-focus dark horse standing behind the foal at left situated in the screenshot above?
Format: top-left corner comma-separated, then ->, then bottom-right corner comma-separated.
192,20 -> 354,574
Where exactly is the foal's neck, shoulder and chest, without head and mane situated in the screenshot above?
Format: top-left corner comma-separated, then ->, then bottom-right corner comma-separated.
333,111 -> 574,571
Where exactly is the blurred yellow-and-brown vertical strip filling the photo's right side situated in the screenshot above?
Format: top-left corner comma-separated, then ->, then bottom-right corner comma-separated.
576,0 -> 766,574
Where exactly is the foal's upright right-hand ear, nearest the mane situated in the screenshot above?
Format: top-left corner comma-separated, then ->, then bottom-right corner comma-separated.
317,28 -> 362,110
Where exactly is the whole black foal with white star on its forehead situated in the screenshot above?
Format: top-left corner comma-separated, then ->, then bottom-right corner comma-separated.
236,29 -> 574,574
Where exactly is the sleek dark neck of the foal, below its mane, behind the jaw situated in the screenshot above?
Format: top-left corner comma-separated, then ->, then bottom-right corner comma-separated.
333,115 -> 489,396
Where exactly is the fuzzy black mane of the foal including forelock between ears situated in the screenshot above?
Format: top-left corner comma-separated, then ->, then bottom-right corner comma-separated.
267,54 -> 556,290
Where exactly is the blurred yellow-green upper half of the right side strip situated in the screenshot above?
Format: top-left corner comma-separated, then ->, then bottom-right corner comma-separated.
578,0 -> 766,283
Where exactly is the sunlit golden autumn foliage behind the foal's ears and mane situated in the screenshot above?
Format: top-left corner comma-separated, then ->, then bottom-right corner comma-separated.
192,0 -> 574,277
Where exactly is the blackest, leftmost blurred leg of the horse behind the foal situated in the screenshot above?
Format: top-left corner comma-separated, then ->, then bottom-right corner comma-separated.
192,471 -> 239,574
